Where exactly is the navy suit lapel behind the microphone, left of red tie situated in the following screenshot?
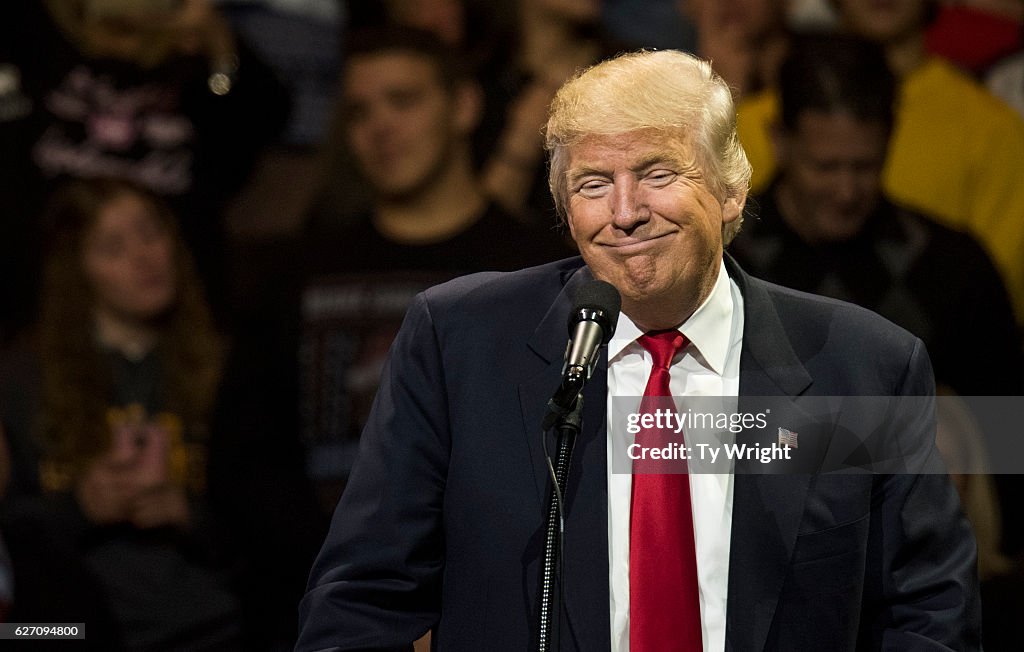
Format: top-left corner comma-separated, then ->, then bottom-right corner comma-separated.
519,267 -> 610,650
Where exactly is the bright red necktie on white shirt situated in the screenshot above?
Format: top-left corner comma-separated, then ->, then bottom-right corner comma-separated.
630,331 -> 702,652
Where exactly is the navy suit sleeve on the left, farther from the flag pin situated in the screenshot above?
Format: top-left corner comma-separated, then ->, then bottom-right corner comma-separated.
295,295 -> 451,652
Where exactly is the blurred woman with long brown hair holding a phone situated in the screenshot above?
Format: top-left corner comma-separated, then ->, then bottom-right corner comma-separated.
0,179 -> 242,650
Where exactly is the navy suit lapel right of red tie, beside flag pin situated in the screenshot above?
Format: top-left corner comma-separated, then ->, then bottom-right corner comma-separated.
726,256 -> 811,650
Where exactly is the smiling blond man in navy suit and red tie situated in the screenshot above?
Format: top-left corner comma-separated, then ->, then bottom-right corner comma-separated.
297,51 -> 980,652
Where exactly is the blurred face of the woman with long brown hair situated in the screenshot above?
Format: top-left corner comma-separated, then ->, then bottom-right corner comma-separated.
82,193 -> 175,321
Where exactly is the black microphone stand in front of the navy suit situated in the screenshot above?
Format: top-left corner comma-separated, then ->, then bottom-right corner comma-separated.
538,395 -> 583,652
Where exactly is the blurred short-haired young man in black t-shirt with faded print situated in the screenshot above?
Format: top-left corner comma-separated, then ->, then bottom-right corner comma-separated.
300,28 -> 573,507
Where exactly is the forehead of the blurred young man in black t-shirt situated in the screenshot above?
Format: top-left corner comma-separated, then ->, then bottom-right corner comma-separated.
342,50 -> 441,97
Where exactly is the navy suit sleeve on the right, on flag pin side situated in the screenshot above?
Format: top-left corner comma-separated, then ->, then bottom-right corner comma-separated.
862,340 -> 981,652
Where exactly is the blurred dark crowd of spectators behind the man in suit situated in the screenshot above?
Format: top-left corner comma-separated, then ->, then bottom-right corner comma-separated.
0,0 -> 1024,651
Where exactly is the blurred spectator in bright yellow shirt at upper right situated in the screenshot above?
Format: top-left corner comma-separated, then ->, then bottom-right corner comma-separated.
737,0 -> 1024,322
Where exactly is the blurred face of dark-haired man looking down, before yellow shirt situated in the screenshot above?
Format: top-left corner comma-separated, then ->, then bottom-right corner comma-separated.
776,110 -> 888,243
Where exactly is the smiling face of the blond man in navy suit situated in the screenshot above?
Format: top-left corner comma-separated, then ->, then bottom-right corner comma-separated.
566,130 -> 741,330
